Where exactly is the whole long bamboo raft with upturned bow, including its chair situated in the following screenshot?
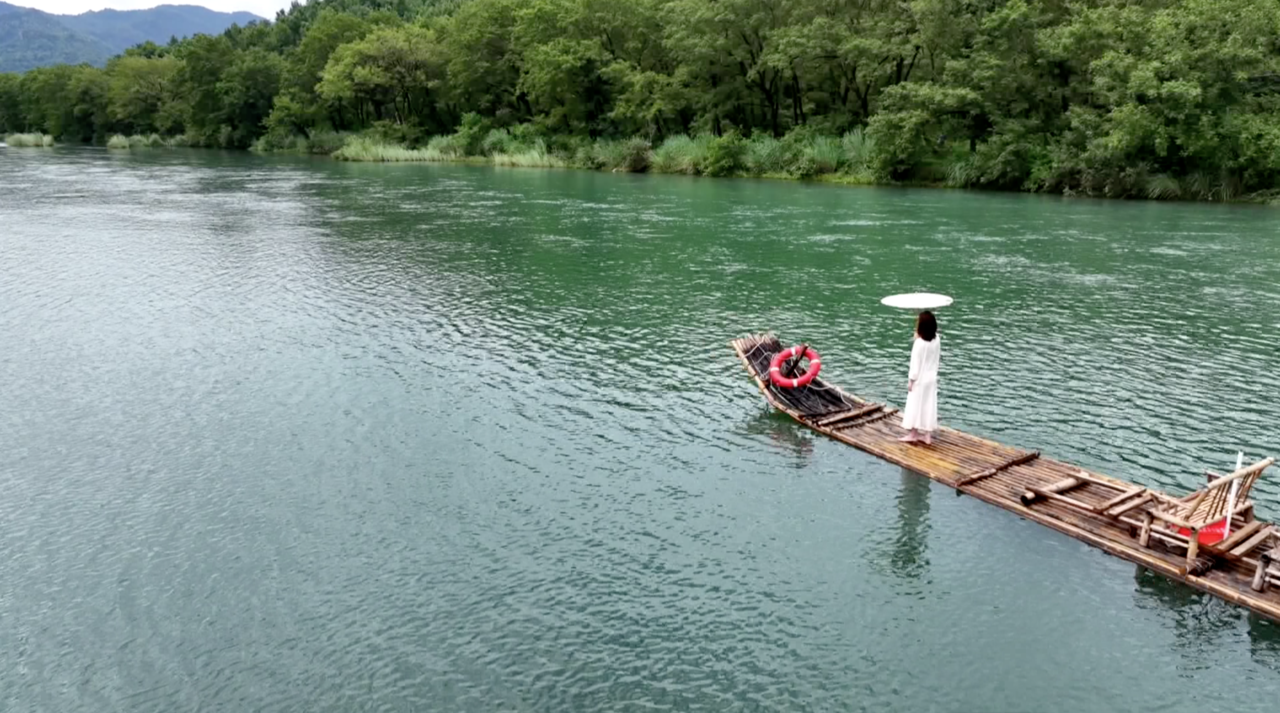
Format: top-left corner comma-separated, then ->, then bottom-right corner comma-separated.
731,334 -> 1280,622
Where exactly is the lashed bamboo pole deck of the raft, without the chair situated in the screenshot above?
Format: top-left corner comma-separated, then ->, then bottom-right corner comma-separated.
732,334 -> 1280,622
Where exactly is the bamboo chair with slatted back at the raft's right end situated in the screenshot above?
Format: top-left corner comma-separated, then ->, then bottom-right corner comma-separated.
1138,458 -> 1275,571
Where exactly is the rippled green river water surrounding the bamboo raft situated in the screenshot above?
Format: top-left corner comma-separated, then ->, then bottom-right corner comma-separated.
0,148 -> 1280,713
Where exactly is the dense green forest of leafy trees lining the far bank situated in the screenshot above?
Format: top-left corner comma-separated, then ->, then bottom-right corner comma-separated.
0,0 -> 1280,200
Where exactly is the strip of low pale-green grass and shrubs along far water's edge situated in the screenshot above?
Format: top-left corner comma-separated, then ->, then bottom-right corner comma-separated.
17,129 -> 1280,206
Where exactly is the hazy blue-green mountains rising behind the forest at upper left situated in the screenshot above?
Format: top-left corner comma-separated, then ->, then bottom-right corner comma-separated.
0,1 -> 262,72
